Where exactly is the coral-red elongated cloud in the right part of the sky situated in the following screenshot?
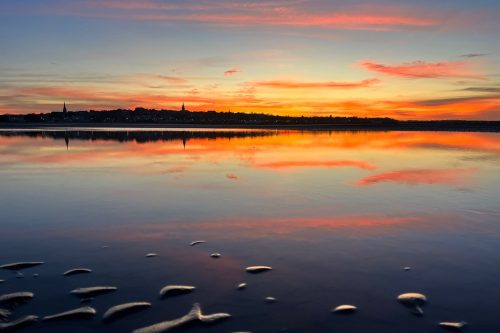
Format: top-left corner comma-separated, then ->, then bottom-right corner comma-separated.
360,60 -> 484,79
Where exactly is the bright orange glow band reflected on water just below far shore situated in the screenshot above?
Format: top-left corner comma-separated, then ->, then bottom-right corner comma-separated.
0,131 -> 500,167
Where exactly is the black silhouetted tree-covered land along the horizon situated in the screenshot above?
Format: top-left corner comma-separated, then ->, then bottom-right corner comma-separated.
0,108 -> 500,132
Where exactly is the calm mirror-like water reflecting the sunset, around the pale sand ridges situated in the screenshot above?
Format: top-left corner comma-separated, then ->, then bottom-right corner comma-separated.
0,130 -> 500,333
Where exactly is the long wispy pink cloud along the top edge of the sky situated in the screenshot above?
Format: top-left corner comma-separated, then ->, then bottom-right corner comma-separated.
8,0 -> 442,31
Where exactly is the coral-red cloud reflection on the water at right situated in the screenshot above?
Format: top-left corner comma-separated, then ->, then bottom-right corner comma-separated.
356,169 -> 475,186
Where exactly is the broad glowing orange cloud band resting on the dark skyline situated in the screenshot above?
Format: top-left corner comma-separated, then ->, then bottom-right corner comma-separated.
0,79 -> 500,120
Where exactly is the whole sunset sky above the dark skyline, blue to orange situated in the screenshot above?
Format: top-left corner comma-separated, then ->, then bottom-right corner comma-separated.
0,0 -> 500,120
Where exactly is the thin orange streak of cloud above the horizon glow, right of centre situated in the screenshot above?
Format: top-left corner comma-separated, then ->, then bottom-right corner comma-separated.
250,78 -> 380,89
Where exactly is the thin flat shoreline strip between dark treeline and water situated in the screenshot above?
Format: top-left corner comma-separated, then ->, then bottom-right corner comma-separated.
0,121 -> 500,133
